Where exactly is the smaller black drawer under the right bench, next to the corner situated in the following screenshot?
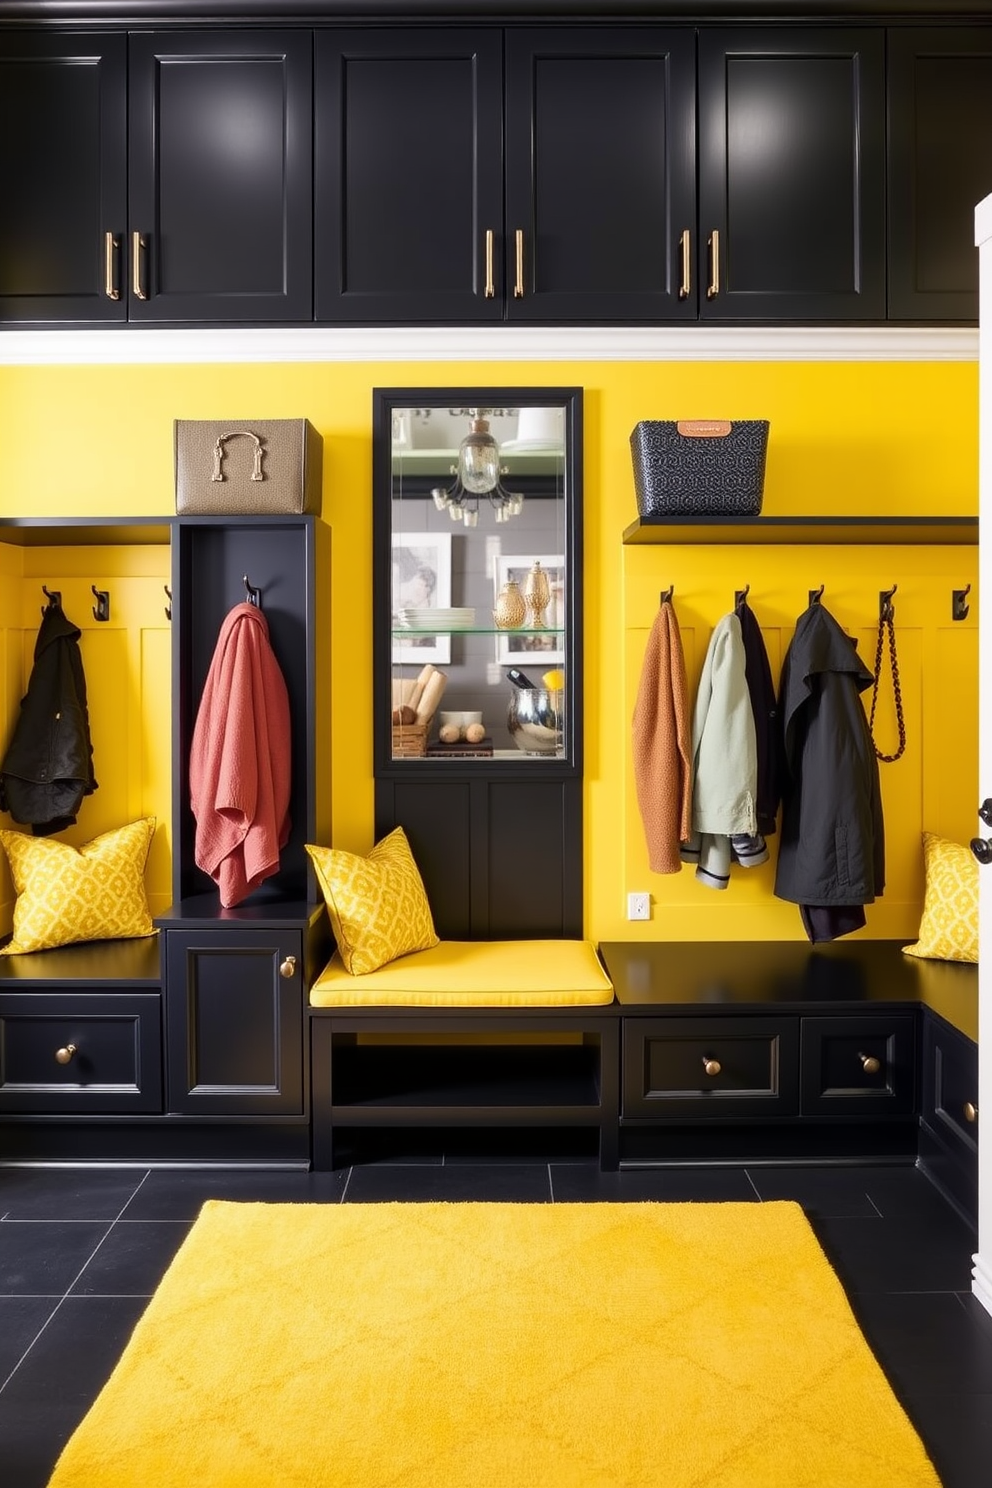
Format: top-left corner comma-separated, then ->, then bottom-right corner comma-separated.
800,1013 -> 916,1116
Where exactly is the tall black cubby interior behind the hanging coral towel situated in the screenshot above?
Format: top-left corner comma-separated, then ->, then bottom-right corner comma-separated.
173,516 -> 318,903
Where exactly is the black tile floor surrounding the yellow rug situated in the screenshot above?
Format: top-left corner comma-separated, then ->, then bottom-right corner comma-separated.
0,1155 -> 992,1488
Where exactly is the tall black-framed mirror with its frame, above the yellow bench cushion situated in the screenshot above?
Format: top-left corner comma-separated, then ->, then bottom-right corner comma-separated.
373,387 -> 582,775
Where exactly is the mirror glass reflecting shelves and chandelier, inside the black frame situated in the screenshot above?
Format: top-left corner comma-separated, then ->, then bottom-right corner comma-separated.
390,397 -> 568,760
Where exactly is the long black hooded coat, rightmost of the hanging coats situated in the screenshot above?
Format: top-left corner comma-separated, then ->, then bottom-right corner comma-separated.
775,604 -> 885,939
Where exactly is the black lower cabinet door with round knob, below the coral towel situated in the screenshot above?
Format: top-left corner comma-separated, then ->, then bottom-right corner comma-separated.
165,927 -> 303,1116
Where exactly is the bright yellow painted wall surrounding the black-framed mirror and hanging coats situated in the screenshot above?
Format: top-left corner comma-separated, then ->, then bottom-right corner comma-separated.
0,362 -> 977,940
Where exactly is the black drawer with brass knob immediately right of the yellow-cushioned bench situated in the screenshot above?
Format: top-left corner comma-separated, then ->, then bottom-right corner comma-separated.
623,1018 -> 799,1120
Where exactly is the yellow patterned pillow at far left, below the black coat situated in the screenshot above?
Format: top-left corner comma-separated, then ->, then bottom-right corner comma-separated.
0,817 -> 155,955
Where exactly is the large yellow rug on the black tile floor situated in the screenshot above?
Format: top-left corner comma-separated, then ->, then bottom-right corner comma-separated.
52,1202 -> 938,1488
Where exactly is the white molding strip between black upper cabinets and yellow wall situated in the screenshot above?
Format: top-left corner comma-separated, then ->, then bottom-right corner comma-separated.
0,326 -> 979,366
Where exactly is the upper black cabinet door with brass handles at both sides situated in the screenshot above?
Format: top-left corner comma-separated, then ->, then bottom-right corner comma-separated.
503,27 -> 696,321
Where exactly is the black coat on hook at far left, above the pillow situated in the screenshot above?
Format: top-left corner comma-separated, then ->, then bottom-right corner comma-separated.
0,604 -> 97,836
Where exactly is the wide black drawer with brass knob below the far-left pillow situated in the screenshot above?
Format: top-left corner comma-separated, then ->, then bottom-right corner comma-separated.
0,991 -> 162,1115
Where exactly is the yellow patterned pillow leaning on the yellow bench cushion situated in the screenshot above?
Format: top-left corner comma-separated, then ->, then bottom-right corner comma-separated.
306,827 -> 437,976
